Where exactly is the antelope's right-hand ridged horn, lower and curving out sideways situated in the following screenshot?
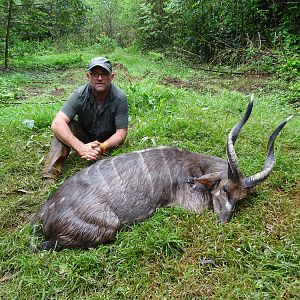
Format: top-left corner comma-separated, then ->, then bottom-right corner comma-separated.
243,116 -> 292,188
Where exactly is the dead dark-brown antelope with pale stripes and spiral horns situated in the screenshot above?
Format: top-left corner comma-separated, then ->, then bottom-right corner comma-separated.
34,99 -> 288,250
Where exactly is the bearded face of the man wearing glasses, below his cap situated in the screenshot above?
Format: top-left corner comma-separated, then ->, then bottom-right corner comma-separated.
87,66 -> 114,94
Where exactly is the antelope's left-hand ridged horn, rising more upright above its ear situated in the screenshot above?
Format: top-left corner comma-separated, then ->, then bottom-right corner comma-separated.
227,94 -> 254,182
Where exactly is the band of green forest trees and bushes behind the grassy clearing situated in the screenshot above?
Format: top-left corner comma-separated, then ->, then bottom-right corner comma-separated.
0,0 -> 300,76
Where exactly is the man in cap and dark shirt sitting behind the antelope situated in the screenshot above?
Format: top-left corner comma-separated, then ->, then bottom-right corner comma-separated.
42,57 -> 128,186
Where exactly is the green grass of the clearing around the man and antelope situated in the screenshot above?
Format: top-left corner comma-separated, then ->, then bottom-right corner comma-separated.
0,49 -> 300,300
